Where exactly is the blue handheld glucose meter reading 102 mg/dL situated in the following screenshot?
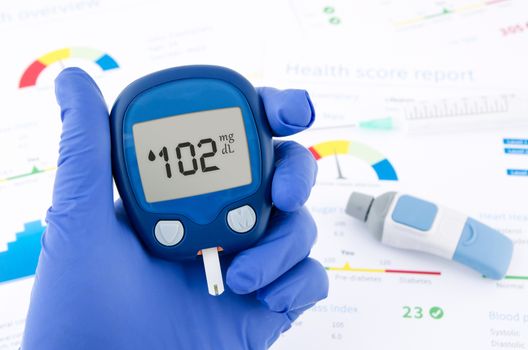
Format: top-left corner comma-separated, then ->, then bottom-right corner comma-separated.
110,66 -> 273,260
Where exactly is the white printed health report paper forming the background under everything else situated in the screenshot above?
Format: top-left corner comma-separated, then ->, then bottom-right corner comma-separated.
0,0 -> 528,350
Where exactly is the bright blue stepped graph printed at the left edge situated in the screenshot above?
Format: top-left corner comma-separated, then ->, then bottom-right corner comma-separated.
0,220 -> 45,282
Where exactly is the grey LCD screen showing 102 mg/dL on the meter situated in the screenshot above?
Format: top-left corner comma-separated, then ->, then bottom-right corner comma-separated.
132,107 -> 252,203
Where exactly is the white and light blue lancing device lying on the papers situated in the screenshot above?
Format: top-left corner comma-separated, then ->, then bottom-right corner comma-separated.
346,192 -> 513,279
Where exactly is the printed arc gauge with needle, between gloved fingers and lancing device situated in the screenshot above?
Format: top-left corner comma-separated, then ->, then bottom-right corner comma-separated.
308,140 -> 398,181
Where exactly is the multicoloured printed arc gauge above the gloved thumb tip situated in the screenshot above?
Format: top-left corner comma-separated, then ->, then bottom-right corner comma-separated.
18,47 -> 119,89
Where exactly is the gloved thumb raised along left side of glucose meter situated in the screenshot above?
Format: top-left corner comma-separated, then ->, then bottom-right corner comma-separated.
48,68 -> 112,232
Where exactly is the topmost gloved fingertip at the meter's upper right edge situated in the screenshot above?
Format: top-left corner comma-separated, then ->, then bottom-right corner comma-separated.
258,87 -> 315,136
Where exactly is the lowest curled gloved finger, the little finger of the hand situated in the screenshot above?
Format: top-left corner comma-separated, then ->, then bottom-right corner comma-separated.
257,258 -> 328,321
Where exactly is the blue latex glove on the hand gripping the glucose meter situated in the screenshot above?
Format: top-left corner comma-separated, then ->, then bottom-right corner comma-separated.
22,68 -> 328,350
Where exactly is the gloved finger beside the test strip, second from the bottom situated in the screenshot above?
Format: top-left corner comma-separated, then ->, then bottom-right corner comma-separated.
226,208 -> 317,294
